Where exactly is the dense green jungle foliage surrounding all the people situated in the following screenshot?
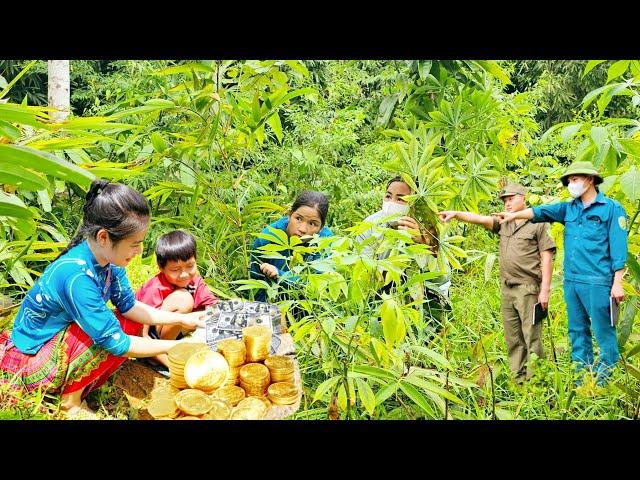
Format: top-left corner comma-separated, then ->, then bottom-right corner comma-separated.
0,60 -> 640,419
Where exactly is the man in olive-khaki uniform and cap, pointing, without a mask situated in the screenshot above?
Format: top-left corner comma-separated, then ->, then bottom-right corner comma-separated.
439,184 -> 555,383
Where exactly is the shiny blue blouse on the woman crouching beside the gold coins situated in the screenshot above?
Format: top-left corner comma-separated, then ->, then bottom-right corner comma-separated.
11,240 -> 136,356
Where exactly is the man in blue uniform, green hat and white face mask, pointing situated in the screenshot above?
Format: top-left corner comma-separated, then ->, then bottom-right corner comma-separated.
500,162 -> 627,385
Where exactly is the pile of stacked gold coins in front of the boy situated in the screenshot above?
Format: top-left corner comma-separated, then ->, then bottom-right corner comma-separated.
147,325 -> 300,420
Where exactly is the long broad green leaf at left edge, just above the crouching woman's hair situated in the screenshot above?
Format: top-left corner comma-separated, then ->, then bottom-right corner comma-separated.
0,144 -> 95,187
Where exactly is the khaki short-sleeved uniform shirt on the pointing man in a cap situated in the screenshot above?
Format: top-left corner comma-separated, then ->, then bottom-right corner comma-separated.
492,218 -> 556,286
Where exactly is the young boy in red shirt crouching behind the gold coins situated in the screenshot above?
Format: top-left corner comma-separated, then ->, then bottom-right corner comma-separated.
136,230 -> 217,367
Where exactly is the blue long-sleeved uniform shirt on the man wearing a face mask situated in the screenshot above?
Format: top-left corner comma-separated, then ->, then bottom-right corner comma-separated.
531,192 -> 628,286
